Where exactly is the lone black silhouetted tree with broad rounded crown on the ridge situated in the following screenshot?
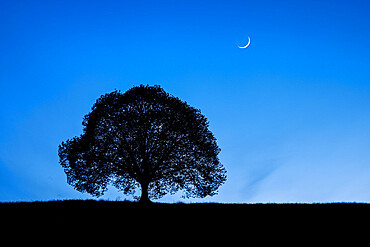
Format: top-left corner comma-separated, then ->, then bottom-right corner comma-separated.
58,85 -> 226,202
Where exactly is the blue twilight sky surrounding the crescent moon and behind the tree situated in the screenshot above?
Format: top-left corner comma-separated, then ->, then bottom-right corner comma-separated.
0,0 -> 370,202
